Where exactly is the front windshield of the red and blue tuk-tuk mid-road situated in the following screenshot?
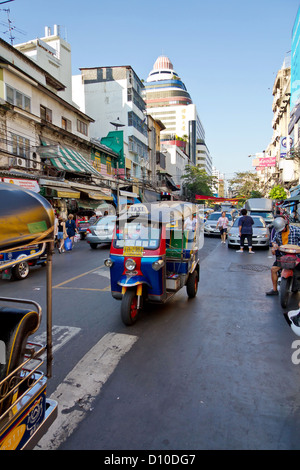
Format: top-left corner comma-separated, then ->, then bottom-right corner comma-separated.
114,219 -> 161,250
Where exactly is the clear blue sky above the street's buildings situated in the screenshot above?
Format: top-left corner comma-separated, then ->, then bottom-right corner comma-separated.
0,0 -> 299,178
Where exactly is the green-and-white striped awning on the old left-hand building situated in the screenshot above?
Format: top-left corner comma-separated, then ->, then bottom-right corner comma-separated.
39,145 -> 101,176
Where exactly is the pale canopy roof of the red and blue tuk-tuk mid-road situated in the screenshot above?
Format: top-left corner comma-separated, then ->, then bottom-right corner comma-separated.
119,201 -> 199,223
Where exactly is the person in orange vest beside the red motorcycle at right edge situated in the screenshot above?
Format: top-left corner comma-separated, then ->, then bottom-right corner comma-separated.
266,217 -> 300,295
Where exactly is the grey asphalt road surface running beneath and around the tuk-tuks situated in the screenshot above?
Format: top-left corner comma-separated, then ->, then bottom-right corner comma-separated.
0,238 -> 300,452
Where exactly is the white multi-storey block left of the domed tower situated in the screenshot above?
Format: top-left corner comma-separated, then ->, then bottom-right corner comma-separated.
72,66 -> 151,178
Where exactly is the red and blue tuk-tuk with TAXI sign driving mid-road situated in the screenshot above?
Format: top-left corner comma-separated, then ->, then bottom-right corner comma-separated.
105,201 -> 203,325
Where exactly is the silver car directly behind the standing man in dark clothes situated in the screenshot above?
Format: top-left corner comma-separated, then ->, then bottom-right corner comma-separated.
227,216 -> 270,249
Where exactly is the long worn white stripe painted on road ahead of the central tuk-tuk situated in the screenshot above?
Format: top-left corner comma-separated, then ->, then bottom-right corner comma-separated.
36,333 -> 138,450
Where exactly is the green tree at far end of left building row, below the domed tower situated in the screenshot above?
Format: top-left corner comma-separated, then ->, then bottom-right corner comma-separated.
181,165 -> 217,201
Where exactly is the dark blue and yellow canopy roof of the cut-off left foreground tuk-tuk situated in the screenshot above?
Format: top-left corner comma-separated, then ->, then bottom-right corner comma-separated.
0,183 -> 54,251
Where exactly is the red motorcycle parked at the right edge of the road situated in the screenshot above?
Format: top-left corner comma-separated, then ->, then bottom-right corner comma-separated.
278,244 -> 300,308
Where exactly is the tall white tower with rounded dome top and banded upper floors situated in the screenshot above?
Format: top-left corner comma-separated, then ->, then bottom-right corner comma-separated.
144,55 -> 211,178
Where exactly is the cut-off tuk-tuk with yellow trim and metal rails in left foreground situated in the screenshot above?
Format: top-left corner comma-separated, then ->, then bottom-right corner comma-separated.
0,183 -> 57,450
